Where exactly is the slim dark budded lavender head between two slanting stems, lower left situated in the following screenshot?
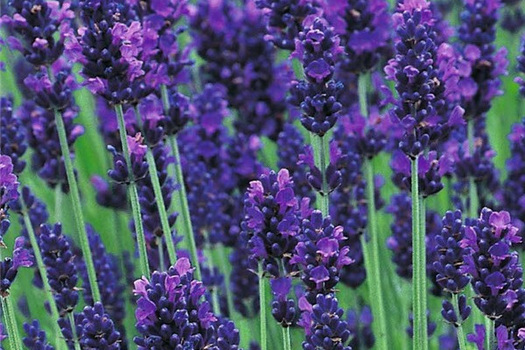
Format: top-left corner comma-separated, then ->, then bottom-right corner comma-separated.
39,224 -> 78,316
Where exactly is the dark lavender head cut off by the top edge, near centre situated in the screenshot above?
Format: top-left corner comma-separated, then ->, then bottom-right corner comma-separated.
255,0 -> 319,51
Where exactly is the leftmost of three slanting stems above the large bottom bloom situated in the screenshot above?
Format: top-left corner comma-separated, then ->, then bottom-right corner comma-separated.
115,104 -> 150,278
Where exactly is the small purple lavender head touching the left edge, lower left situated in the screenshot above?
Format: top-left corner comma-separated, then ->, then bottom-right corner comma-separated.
0,237 -> 33,298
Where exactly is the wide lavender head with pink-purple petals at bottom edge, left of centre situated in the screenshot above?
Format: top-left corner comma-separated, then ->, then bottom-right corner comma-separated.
134,258 -> 238,350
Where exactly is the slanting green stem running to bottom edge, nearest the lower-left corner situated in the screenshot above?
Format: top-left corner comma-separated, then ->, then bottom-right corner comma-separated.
20,200 -> 67,349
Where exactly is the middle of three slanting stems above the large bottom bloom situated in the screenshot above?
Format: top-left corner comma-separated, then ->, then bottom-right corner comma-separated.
146,147 -> 177,265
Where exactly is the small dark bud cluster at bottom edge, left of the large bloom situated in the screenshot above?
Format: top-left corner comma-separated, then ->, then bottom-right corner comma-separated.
79,302 -> 122,350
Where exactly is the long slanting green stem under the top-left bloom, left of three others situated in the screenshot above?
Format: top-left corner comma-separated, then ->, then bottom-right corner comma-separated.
55,110 -> 100,302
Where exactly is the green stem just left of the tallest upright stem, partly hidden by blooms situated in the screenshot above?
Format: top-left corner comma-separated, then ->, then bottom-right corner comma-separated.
358,74 -> 388,350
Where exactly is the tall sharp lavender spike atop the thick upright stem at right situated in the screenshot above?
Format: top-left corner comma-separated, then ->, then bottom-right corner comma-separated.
385,0 -> 444,158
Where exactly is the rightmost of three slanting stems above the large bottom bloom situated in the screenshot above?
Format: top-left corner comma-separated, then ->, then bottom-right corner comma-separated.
160,85 -> 202,280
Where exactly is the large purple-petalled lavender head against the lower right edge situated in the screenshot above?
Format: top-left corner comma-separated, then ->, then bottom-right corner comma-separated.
460,208 -> 525,344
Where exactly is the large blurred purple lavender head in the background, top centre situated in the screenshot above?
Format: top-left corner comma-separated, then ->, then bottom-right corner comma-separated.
190,0 -> 290,140
